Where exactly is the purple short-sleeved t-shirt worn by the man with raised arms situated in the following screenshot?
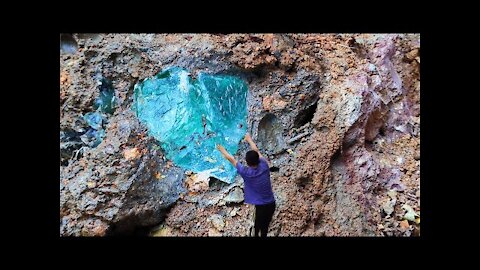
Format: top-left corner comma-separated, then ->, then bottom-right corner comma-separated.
237,158 -> 275,205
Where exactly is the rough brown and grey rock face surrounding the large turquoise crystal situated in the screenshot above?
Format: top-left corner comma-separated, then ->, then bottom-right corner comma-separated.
60,34 -> 420,236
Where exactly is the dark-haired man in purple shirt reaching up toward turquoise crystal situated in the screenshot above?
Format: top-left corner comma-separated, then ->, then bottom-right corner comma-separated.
217,133 -> 275,237
